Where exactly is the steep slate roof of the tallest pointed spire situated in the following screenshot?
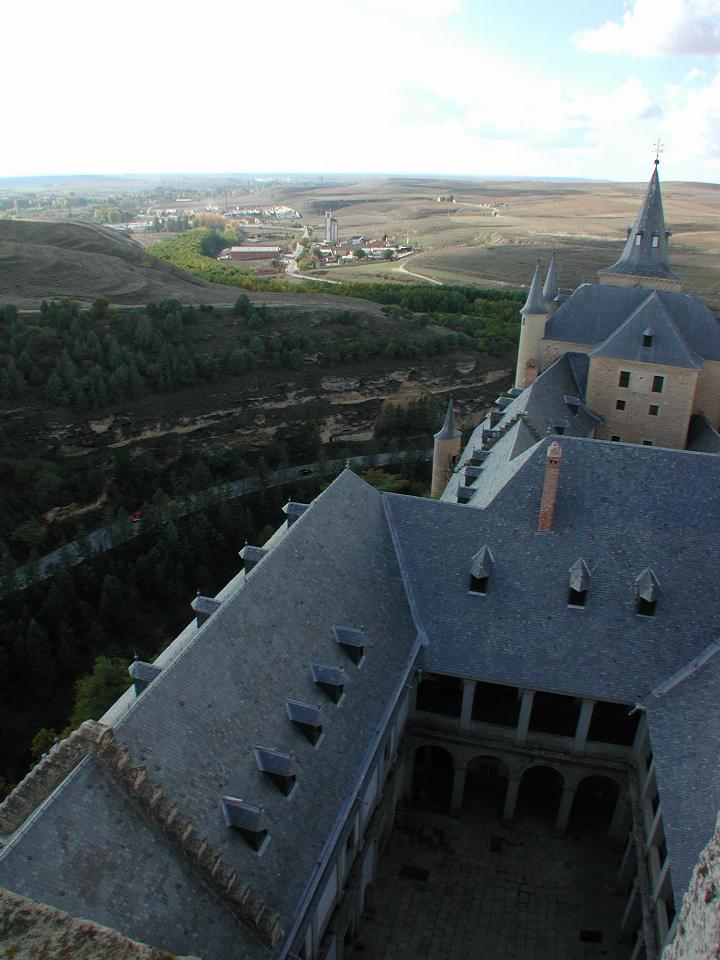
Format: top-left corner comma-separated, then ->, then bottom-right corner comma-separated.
600,163 -> 680,280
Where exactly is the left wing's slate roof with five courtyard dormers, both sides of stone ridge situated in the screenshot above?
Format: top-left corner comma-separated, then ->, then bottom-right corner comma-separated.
0,471 -> 417,960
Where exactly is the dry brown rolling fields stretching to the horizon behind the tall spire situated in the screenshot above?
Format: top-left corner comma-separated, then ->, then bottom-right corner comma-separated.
276,171 -> 720,307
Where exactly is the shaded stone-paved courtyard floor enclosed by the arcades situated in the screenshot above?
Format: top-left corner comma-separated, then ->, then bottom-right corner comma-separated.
346,810 -> 630,960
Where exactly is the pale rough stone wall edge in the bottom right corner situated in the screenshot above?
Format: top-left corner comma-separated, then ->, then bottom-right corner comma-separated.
662,817 -> 720,960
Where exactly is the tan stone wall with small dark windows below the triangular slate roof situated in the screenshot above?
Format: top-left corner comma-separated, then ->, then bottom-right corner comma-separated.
587,357 -> 698,449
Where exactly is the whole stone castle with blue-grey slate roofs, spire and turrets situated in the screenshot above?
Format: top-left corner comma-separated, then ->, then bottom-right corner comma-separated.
0,168 -> 720,960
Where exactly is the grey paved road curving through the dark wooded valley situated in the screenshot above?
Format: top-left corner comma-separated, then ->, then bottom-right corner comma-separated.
7,450 -> 432,590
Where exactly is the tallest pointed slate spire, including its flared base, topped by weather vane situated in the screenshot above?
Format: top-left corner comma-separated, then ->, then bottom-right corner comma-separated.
598,159 -> 682,291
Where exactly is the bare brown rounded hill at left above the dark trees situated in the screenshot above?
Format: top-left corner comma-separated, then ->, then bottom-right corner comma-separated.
0,220 -> 248,307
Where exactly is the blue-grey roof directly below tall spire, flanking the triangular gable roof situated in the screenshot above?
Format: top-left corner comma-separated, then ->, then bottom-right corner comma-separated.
544,283 -> 720,360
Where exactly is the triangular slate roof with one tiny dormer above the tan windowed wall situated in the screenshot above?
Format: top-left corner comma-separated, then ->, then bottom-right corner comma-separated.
590,291 -> 702,370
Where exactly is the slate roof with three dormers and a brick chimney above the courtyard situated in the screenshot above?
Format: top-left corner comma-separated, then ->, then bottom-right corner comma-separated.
388,437 -> 720,703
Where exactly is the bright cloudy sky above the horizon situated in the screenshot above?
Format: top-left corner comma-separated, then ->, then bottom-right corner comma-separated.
0,0 -> 720,182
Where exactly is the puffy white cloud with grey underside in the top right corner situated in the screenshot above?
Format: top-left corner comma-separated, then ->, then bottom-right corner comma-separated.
573,0 -> 720,57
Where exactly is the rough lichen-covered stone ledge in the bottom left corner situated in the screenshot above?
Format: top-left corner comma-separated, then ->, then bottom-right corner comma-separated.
0,888 -> 197,960
